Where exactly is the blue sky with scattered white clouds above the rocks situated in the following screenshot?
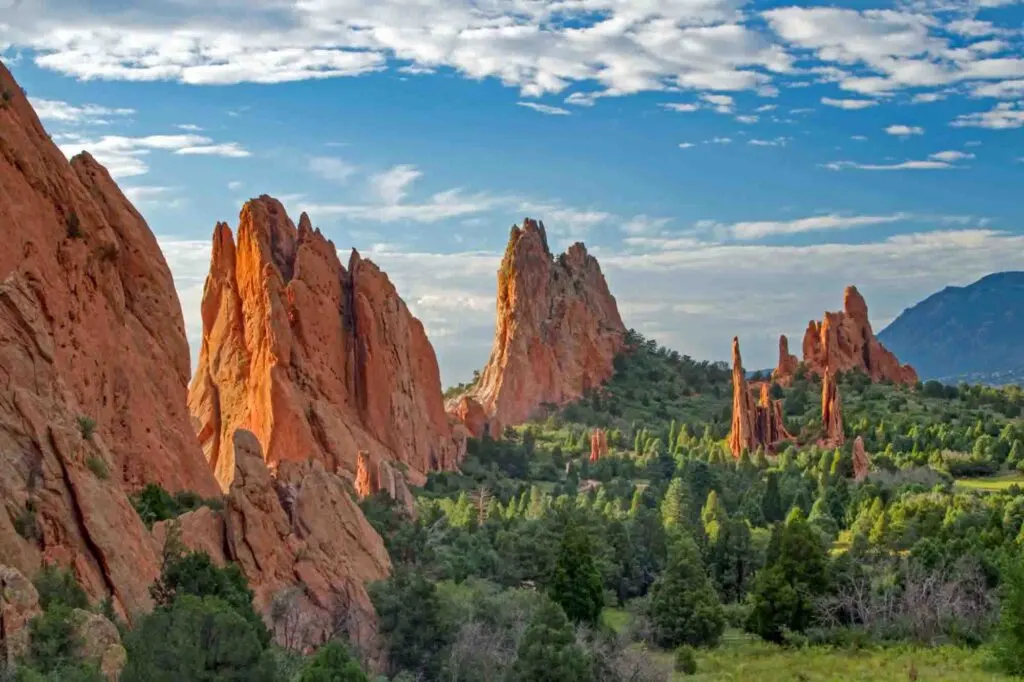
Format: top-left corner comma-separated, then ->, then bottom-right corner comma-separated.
0,0 -> 1024,383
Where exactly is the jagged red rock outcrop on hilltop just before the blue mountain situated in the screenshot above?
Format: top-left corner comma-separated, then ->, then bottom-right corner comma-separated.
772,286 -> 918,384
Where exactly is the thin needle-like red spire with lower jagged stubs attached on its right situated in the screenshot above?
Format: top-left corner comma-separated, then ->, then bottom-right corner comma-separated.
729,337 -> 793,457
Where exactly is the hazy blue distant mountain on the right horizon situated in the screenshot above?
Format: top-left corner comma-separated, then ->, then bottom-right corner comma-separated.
879,271 -> 1024,384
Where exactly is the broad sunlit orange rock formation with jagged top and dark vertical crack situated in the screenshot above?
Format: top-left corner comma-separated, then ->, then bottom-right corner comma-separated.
188,197 -> 464,488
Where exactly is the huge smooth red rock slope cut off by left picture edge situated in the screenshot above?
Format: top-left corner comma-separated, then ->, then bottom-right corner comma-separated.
0,65 -> 218,617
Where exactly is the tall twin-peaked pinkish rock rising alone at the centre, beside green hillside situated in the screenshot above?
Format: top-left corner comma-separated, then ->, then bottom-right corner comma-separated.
454,218 -> 626,425
